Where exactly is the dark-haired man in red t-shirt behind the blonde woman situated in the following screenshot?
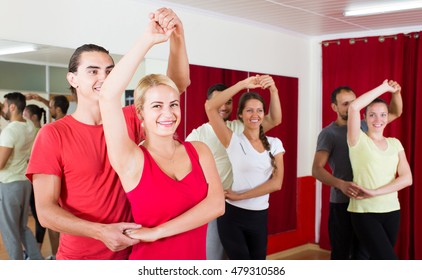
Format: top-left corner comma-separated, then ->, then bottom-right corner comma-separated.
26,8 -> 190,260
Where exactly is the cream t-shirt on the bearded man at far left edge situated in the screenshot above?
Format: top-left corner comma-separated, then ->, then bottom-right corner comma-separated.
0,121 -> 35,183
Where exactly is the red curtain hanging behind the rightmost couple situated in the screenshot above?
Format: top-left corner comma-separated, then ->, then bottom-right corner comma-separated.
320,32 -> 422,259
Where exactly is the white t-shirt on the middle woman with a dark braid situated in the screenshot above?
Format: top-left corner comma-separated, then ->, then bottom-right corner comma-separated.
227,133 -> 285,210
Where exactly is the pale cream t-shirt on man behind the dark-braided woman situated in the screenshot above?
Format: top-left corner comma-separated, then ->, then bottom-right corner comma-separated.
186,120 -> 244,190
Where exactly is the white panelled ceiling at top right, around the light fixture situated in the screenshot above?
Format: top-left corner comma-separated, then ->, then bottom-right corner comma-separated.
165,0 -> 422,36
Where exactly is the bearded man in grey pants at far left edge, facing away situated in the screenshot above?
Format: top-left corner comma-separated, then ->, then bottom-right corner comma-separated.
0,92 -> 43,260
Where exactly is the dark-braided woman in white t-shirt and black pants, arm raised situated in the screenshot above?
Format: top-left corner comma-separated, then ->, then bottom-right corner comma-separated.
205,75 -> 284,260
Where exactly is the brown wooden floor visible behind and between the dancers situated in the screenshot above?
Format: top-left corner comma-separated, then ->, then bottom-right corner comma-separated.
0,216 -> 330,260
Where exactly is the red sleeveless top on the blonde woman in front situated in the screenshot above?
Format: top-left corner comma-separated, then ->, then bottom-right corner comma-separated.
127,142 -> 208,260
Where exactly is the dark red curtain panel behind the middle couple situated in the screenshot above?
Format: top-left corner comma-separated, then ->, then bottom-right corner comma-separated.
183,65 -> 298,234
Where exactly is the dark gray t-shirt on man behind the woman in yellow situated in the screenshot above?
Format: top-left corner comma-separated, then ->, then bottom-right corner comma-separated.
316,121 -> 368,203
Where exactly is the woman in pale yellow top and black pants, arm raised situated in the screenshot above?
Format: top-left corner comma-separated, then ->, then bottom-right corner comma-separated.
347,80 -> 412,259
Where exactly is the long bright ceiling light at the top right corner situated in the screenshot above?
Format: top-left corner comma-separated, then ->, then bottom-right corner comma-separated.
343,1 -> 422,17
